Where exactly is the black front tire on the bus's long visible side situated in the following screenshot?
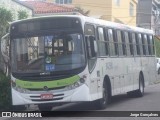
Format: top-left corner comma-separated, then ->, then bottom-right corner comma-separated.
95,82 -> 109,109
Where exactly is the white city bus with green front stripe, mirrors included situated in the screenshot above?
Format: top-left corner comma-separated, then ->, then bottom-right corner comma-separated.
1,15 -> 156,110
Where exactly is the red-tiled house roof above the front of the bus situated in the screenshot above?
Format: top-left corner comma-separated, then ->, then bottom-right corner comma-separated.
23,1 -> 78,16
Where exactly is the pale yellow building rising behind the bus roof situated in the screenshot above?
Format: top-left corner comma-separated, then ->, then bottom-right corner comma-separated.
46,0 -> 138,26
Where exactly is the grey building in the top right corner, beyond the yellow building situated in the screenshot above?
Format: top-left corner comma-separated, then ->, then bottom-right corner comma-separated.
137,0 -> 160,35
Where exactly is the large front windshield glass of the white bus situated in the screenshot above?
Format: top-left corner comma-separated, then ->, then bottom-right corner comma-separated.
12,32 -> 85,73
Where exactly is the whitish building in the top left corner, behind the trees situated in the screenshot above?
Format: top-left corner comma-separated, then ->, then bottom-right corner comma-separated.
0,0 -> 33,20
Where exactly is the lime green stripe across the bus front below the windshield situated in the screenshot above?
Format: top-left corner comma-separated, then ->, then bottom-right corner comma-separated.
16,75 -> 80,89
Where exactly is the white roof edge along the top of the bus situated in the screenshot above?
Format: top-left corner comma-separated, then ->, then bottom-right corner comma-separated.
11,15 -> 153,34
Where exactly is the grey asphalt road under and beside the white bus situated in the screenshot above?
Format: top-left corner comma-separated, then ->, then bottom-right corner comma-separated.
0,79 -> 160,120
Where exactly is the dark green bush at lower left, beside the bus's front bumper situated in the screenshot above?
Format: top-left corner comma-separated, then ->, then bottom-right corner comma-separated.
0,72 -> 11,111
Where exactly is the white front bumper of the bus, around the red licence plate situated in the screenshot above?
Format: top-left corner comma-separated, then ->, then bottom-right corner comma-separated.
12,84 -> 91,105
